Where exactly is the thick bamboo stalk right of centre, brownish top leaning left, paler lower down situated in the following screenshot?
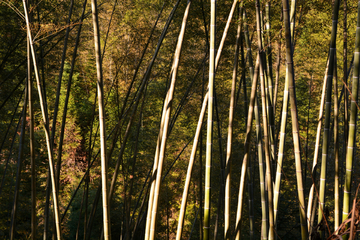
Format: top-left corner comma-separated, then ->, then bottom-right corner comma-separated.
282,0 -> 308,240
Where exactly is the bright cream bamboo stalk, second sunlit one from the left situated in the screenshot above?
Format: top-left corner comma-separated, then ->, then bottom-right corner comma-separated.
91,0 -> 111,240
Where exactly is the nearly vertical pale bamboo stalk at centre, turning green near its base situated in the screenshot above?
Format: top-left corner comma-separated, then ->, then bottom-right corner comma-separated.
204,0 -> 216,237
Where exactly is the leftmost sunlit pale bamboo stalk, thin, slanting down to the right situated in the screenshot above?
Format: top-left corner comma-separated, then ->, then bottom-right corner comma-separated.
23,0 -> 61,240
